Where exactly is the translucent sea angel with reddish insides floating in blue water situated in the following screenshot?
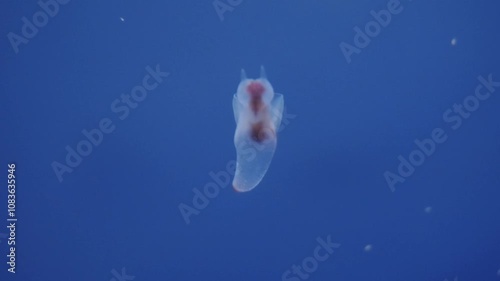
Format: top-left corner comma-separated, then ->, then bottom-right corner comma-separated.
233,66 -> 284,192
